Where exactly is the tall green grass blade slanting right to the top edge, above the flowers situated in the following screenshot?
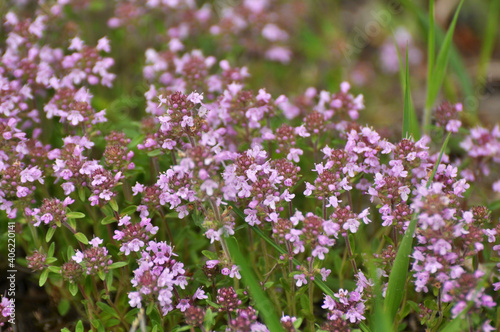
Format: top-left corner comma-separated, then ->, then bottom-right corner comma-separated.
422,0 -> 464,133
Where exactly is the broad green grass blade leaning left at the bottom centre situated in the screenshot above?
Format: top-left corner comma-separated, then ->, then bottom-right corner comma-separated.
226,236 -> 285,332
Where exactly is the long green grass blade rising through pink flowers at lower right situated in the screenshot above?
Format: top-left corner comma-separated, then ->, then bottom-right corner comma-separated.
384,133 -> 451,321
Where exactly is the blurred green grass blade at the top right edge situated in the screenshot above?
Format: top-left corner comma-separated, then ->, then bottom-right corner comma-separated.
476,0 -> 500,84
